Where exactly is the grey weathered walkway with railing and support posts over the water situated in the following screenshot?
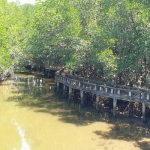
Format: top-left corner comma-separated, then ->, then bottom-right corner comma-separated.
55,73 -> 150,119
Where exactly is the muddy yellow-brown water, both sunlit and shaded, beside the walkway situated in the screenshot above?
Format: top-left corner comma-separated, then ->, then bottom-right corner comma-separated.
0,74 -> 150,150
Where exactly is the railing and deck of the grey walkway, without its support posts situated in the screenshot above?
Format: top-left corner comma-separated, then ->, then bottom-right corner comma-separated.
55,74 -> 150,104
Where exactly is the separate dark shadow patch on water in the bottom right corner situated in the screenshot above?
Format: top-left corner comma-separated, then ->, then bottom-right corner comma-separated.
94,119 -> 150,150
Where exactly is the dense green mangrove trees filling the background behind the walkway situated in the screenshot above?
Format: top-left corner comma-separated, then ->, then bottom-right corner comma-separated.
0,0 -> 150,88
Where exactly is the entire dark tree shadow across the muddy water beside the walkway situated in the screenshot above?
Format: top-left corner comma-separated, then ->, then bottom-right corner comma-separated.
5,72 -> 150,150
